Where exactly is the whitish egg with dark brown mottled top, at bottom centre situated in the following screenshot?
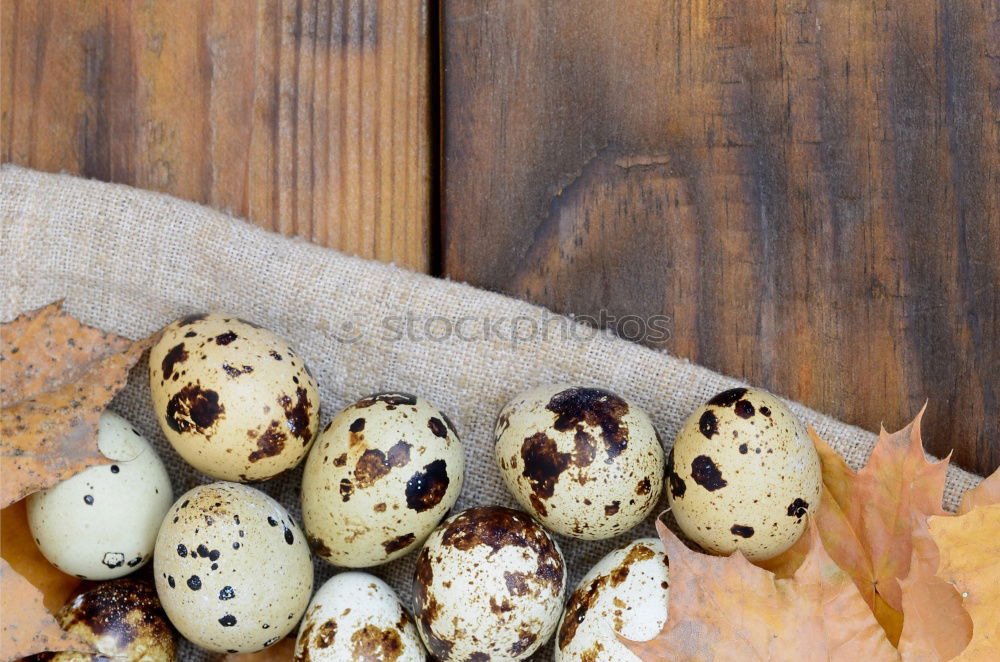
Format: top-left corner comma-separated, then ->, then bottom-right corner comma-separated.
413,506 -> 566,662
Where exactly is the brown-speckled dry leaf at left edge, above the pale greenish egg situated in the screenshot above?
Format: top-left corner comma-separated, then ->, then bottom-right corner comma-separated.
0,301 -> 149,507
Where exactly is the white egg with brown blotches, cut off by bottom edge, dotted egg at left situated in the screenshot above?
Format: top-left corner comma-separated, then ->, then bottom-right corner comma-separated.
295,572 -> 427,662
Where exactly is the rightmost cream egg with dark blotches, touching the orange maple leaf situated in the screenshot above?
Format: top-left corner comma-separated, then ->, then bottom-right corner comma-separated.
667,388 -> 822,561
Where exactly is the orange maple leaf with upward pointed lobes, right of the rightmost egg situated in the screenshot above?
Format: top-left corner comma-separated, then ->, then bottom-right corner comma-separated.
764,409 -> 948,643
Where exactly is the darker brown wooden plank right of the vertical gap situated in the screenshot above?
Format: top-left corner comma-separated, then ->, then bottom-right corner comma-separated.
442,0 -> 1000,473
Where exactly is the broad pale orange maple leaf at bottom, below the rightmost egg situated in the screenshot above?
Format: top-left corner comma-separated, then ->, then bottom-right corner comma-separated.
623,522 -> 899,662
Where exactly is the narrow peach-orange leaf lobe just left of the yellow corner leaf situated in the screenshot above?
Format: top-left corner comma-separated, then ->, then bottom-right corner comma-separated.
899,517 -> 972,662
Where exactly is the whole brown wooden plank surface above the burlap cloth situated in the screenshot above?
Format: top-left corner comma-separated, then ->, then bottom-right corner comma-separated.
0,0 -> 1000,473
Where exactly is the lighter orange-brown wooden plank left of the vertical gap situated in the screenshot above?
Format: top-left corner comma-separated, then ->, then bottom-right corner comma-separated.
0,0 -> 431,271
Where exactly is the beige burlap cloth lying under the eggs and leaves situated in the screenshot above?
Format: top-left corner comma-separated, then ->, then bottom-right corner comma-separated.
0,165 -> 980,660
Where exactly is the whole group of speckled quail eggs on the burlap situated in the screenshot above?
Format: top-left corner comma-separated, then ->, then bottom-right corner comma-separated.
28,314 -> 820,662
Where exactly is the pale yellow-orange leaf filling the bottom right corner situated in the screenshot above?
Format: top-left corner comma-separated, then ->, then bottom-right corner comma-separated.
928,503 -> 1000,662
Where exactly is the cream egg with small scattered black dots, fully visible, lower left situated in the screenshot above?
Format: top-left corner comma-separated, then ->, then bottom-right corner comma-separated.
153,483 -> 313,653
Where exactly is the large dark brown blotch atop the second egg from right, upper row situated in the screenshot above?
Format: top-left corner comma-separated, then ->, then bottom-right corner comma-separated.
545,387 -> 628,464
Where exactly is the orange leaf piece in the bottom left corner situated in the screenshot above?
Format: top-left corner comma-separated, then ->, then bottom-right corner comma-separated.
0,560 -> 96,662
